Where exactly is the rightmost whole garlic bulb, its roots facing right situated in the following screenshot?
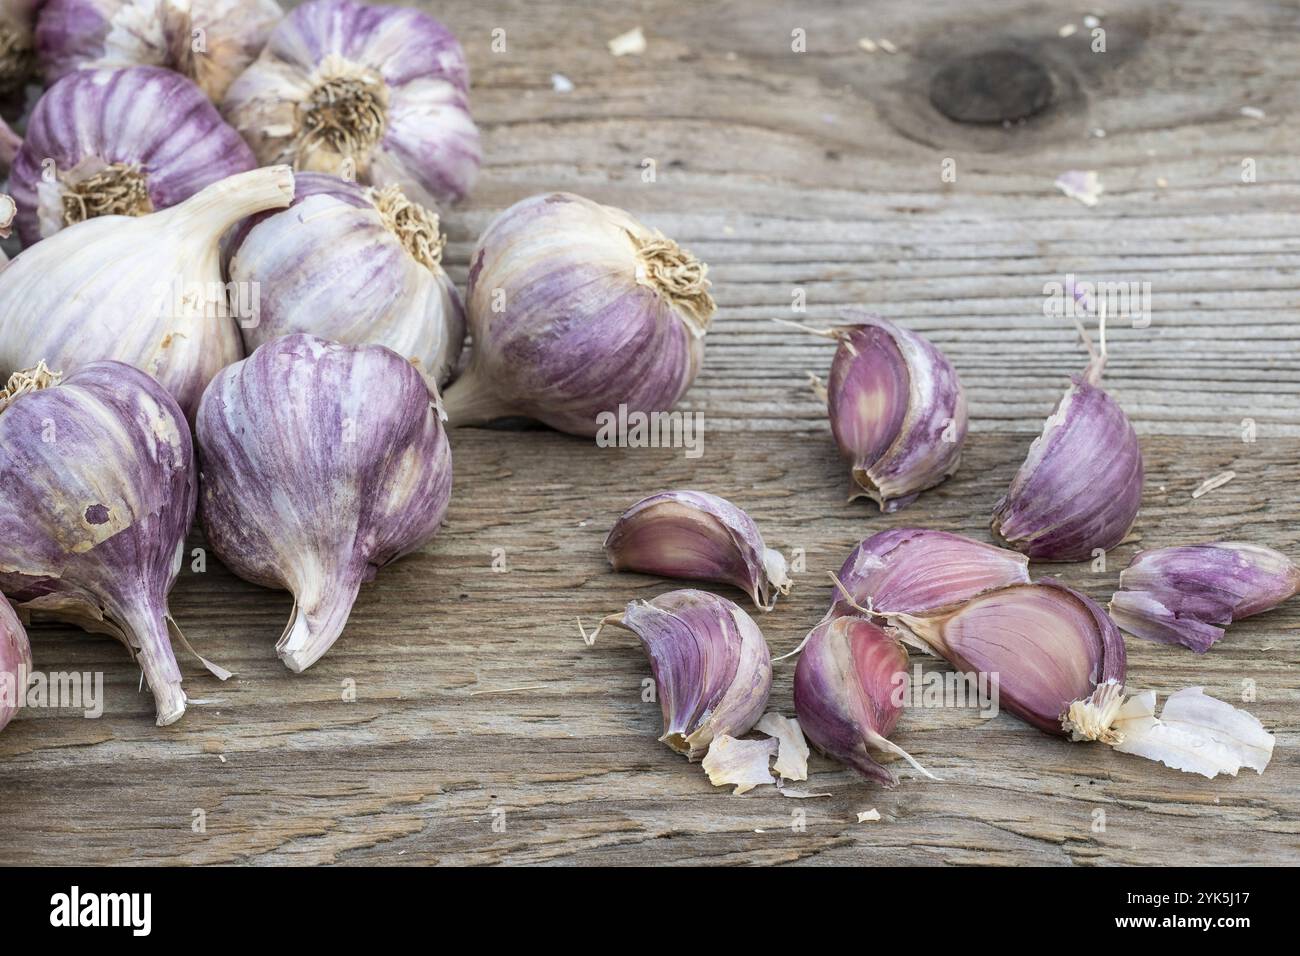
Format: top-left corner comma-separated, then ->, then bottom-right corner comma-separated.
446,193 -> 715,436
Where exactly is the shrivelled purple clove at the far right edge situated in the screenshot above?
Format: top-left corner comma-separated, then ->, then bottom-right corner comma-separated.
1110,541 -> 1300,654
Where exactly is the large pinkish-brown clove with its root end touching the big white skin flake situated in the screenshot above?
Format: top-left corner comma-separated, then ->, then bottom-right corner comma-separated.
906,579 -> 1127,735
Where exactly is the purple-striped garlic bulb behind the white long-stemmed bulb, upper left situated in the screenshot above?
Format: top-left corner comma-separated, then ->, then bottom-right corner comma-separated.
9,66 -> 257,246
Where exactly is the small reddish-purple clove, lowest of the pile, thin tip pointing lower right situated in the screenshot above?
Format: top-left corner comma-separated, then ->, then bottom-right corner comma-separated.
794,617 -> 933,787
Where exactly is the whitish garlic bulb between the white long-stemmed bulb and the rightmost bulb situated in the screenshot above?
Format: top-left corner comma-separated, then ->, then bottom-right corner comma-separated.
228,173 -> 465,385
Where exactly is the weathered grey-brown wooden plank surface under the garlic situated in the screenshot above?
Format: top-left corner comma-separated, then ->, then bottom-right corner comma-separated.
0,0 -> 1300,865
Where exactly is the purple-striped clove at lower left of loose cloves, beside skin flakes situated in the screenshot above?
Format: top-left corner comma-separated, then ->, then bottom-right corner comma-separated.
602,589 -> 772,760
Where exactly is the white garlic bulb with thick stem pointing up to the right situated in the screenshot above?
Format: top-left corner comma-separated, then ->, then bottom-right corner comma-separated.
0,166 -> 294,416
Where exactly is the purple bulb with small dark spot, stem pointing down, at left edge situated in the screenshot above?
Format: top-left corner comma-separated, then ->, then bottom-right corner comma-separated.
0,362 -> 198,727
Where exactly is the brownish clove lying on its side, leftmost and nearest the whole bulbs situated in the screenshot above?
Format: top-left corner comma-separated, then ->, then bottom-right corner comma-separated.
605,492 -> 790,611
